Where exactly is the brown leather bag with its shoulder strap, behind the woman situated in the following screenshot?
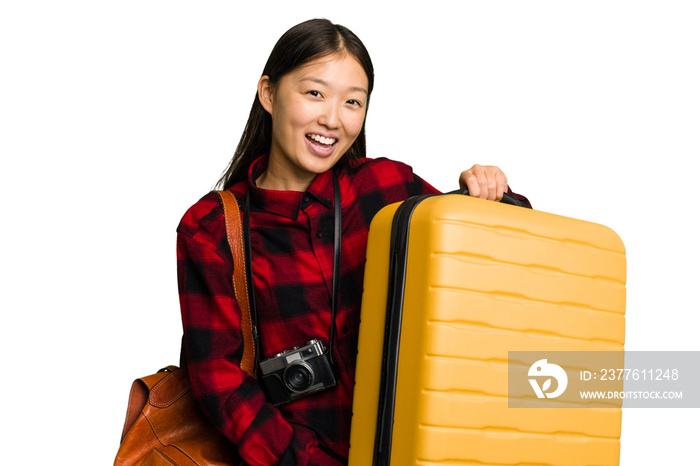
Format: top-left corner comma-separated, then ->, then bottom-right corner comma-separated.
114,191 -> 255,466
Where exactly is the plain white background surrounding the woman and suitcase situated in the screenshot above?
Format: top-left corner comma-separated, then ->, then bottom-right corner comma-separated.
0,0 -> 700,466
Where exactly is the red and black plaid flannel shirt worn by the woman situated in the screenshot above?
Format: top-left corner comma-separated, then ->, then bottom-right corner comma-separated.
177,157 -> 528,465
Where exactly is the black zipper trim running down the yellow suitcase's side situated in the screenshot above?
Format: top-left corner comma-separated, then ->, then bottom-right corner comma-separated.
372,194 -> 432,466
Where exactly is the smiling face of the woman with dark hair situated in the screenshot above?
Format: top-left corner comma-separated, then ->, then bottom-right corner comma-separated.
257,54 -> 369,191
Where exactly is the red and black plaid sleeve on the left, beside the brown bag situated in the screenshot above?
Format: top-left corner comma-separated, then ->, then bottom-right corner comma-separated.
177,196 -> 340,465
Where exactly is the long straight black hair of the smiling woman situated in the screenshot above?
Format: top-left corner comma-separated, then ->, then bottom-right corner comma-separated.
217,19 -> 374,189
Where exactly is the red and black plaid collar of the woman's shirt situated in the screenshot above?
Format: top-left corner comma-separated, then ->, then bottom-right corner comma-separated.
248,155 -> 333,220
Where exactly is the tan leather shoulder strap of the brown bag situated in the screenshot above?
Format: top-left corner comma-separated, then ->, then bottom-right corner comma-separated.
217,191 -> 255,377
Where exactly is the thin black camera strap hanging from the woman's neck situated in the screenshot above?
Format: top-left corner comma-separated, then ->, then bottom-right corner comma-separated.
243,169 -> 342,367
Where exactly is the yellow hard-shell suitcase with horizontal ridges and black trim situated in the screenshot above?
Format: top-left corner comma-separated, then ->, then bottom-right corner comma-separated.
349,191 -> 626,466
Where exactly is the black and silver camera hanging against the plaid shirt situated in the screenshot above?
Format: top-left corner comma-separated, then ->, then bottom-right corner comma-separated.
260,339 -> 338,406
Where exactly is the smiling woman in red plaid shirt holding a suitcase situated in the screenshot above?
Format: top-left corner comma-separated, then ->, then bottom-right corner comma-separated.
178,20 -> 528,465
